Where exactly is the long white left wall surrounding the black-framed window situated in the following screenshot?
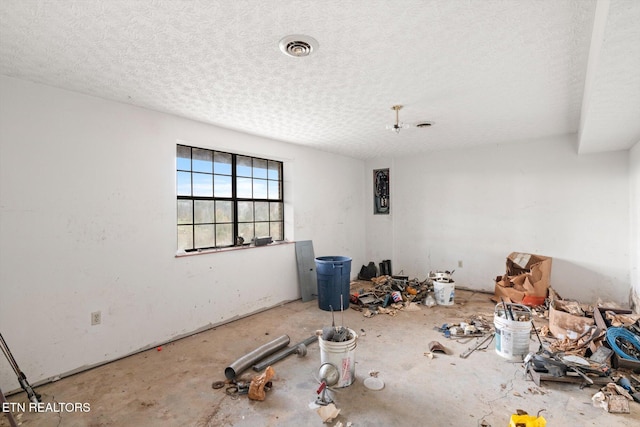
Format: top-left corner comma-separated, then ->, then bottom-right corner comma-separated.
0,77 -> 365,391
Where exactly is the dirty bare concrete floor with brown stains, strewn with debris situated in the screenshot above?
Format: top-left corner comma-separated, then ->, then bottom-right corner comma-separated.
0,290 -> 640,427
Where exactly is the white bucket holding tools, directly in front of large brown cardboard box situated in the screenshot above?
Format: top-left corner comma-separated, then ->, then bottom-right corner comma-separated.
493,304 -> 531,361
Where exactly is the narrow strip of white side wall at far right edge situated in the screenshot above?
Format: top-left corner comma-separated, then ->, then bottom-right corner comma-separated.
629,142 -> 640,313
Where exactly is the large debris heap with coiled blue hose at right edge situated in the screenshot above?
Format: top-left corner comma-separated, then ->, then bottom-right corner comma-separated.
524,288 -> 640,413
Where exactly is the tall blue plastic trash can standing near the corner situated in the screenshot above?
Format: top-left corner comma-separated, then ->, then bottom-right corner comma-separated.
316,256 -> 351,311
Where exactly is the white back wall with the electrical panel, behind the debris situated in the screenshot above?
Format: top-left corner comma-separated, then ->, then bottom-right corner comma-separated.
365,137 -> 630,304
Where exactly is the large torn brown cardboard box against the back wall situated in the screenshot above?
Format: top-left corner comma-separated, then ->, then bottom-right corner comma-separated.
492,252 -> 552,305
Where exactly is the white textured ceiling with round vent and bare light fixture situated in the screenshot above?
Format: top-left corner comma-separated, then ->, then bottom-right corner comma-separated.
0,0 -> 640,158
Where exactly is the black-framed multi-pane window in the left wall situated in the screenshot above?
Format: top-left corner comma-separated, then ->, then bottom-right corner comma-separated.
176,144 -> 284,252
